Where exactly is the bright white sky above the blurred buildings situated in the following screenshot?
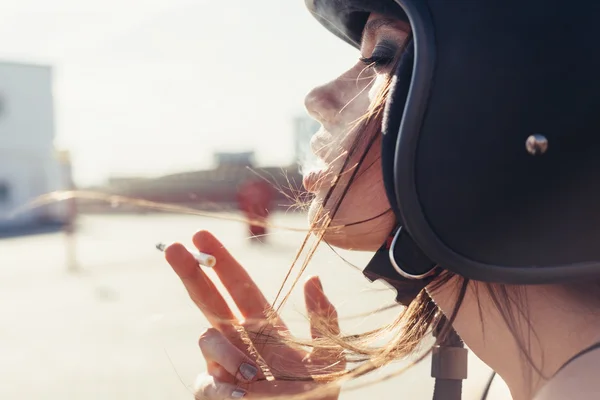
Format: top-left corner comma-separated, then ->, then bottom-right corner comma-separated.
0,0 -> 358,184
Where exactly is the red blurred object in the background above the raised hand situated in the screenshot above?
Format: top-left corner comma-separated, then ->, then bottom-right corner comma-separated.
237,179 -> 274,239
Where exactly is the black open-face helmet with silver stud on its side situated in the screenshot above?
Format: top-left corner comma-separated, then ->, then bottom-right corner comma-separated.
306,0 -> 600,284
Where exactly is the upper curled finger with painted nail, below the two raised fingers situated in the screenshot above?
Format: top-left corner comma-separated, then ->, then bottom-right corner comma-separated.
198,329 -> 263,382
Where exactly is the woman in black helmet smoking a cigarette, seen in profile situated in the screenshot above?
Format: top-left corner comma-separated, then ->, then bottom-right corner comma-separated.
166,0 -> 600,400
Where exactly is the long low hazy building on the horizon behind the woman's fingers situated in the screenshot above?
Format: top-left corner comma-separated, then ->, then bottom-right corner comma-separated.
79,115 -> 320,213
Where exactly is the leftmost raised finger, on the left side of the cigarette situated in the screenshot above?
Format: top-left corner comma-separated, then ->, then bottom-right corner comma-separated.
165,243 -> 237,337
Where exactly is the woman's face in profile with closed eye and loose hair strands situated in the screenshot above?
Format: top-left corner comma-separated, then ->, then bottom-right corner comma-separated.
304,14 -> 409,250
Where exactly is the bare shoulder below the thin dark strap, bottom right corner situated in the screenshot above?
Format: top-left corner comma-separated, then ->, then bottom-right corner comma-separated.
535,351 -> 600,400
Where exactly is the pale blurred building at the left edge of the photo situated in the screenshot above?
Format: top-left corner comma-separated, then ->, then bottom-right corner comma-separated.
0,62 -> 71,228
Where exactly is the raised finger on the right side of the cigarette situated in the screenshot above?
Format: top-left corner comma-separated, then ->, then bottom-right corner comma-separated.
193,231 -> 284,328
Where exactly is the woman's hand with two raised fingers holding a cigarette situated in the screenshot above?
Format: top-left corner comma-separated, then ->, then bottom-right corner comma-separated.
165,231 -> 346,400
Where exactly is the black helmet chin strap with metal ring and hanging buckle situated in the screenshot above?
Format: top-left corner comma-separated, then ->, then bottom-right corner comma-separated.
363,225 -> 467,400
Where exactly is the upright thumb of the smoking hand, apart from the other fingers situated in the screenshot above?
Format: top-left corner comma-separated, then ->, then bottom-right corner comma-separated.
304,276 -> 340,339
